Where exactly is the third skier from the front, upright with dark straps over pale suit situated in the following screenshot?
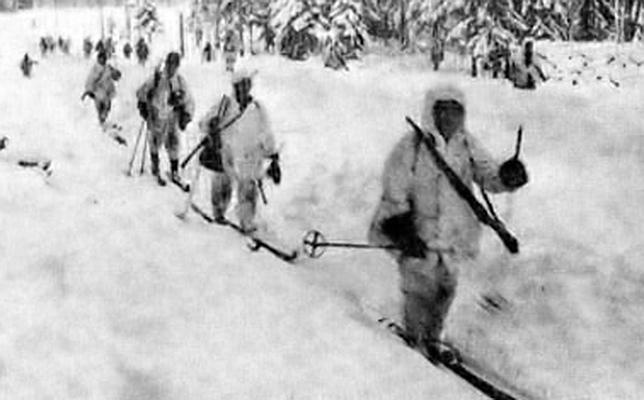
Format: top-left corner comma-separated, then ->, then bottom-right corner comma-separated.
136,52 -> 195,185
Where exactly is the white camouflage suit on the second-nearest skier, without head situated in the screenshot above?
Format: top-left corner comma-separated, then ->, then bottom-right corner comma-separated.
199,96 -> 277,231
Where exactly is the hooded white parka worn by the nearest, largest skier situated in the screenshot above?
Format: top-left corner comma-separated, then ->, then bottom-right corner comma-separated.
369,86 -> 510,258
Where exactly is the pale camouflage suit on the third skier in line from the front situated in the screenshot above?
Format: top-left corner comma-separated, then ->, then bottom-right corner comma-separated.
136,71 -> 195,166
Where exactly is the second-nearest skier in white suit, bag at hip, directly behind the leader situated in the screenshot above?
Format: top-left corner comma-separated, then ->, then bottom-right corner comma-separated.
199,70 -> 281,232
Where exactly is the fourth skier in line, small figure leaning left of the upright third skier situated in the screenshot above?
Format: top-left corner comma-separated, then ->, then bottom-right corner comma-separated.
81,51 -> 121,129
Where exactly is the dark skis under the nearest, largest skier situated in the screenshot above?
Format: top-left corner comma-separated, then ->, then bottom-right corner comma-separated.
378,318 -> 536,400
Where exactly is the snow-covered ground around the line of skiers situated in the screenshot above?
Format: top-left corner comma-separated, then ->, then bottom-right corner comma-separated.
0,6 -> 644,400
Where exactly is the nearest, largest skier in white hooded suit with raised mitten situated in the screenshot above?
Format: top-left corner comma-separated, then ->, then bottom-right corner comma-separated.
369,86 -> 528,357
